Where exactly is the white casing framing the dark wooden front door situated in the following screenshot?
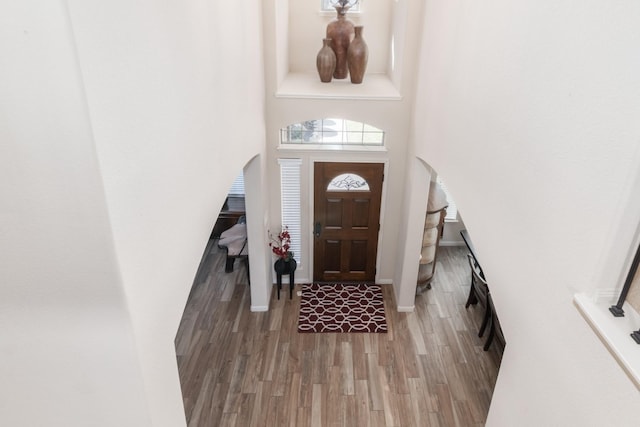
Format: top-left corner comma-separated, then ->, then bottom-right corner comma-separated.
306,157 -> 390,284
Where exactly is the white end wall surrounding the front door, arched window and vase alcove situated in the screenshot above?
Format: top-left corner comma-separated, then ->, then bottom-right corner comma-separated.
263,0 -> 421,285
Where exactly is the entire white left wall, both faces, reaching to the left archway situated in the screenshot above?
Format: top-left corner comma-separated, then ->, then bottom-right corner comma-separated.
0,0 -> 267,427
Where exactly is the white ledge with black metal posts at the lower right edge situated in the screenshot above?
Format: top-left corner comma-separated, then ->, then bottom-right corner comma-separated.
573,293 -> 640,390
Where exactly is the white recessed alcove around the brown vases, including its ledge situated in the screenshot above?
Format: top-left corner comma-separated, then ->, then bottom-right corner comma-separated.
274,0 -> 408,100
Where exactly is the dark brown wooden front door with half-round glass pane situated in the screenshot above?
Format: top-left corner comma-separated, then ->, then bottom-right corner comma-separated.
313,162 -> 384,282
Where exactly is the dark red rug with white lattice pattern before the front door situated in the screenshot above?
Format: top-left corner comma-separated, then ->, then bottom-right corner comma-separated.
298,283 -> 387,332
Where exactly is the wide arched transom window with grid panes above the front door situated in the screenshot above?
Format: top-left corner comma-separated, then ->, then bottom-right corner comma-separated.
280,118 -> 384,147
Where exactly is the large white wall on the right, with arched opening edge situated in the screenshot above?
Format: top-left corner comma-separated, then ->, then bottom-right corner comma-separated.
415,0 -> 640,427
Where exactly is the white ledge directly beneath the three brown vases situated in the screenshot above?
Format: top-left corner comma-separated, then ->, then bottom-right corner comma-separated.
275,73 -> 402,100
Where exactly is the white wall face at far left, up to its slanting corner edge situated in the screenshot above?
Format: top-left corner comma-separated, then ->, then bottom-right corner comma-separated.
0,1 -> 150,427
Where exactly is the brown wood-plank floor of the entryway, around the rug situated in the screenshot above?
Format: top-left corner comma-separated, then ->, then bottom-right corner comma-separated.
176,244 -> 502,427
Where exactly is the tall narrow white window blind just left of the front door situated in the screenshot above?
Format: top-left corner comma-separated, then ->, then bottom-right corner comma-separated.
278,159 -> 302,264
